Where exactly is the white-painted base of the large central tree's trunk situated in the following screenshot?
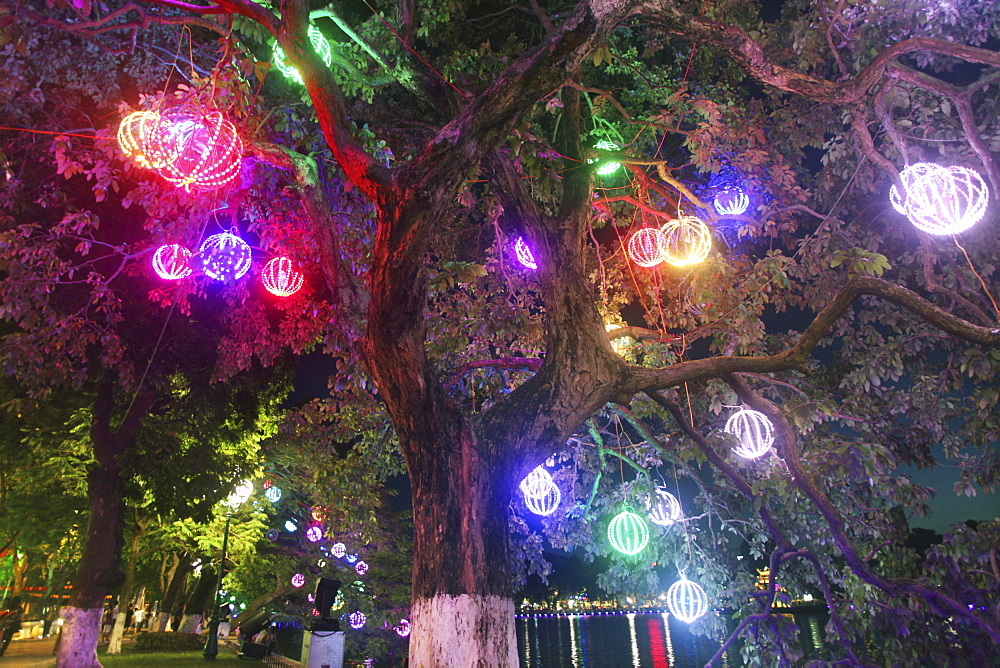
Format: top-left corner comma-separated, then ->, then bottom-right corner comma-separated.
410,594 -> 518,668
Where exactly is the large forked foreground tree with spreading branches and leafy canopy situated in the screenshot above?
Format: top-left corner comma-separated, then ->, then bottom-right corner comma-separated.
1,0 -> 1000,666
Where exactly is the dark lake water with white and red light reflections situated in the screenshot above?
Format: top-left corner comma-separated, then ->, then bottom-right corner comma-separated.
516,612 -> 826,668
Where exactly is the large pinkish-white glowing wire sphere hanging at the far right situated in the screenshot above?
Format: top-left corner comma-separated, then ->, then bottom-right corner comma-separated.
889,162 -> 990,235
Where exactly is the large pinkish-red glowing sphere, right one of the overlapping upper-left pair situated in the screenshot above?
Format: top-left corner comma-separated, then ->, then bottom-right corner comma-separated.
154,107 -> 243,192
